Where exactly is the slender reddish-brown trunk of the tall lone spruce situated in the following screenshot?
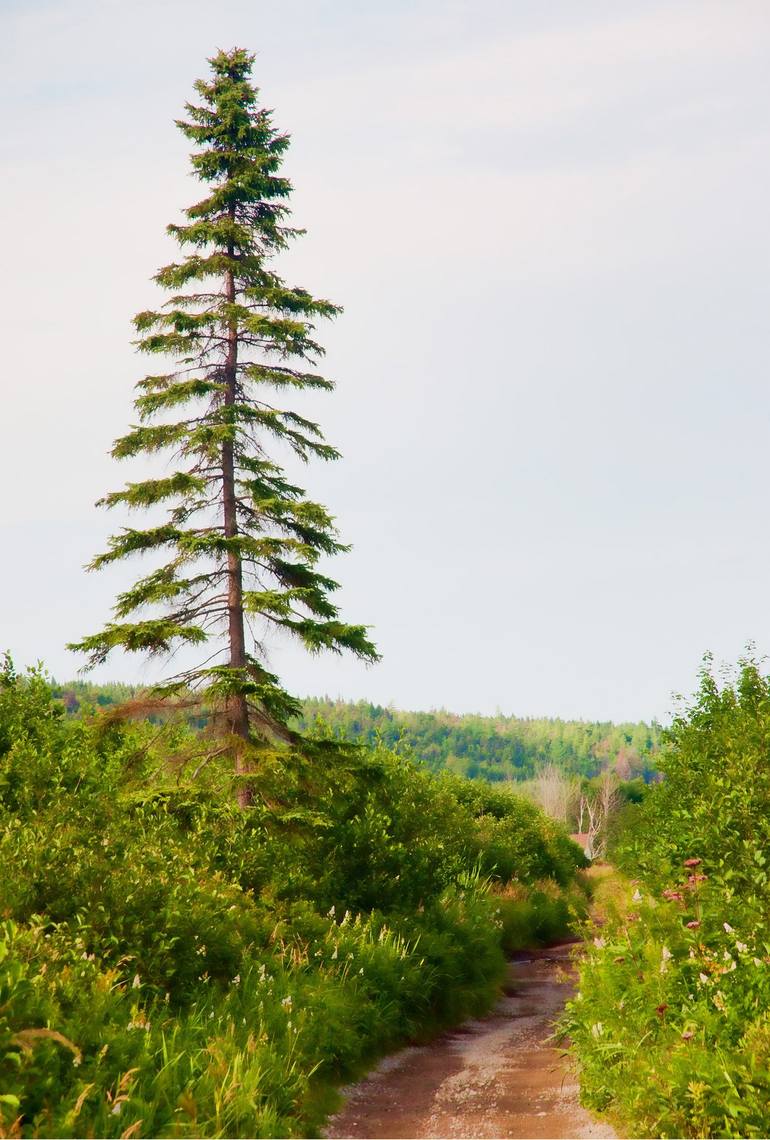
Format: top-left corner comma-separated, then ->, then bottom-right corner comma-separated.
221,235 -> 252,807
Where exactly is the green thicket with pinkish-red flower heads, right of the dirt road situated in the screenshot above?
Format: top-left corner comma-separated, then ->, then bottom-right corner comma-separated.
566,661 -> 770,1137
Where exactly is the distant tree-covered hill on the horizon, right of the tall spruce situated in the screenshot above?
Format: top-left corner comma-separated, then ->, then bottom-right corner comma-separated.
301,698 -> 660,781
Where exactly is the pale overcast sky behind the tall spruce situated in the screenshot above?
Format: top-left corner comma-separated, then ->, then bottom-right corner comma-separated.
0,0 -> 770,719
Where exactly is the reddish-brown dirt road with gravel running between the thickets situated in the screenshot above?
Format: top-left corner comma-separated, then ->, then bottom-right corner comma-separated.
326,946 -> 615,1140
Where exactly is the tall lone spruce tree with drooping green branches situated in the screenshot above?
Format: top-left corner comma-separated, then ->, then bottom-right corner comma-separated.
70,48 -> 378,803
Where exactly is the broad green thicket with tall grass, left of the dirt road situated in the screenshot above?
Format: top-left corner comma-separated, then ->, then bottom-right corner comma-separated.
0,663 -> 583,1138
